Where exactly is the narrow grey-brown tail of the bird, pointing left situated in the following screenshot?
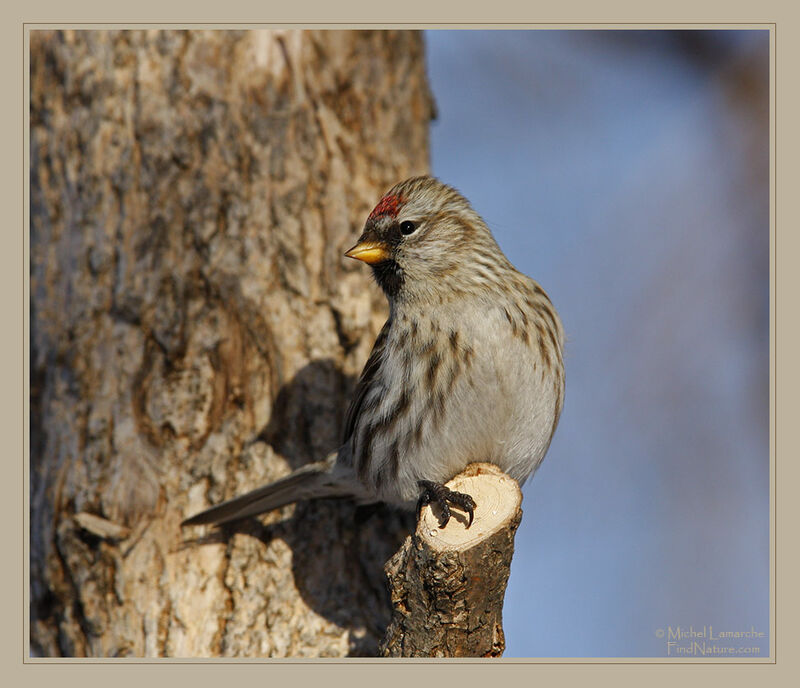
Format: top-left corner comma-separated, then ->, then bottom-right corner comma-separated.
186,454 -> 352,526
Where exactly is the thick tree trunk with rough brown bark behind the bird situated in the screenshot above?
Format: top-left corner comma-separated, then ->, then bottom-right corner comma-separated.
30,31 -> 432,657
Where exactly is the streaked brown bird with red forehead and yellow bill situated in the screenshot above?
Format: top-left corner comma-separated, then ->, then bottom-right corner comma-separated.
181,176 -> 565,528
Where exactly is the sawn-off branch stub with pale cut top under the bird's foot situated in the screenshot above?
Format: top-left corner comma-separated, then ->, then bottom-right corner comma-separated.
381,464 -> 522,657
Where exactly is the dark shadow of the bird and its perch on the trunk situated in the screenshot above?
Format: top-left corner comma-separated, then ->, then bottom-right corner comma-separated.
186,359 -> 414,656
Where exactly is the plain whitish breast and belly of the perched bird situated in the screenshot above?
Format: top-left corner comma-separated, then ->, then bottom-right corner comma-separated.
362,308 -> 561,502
